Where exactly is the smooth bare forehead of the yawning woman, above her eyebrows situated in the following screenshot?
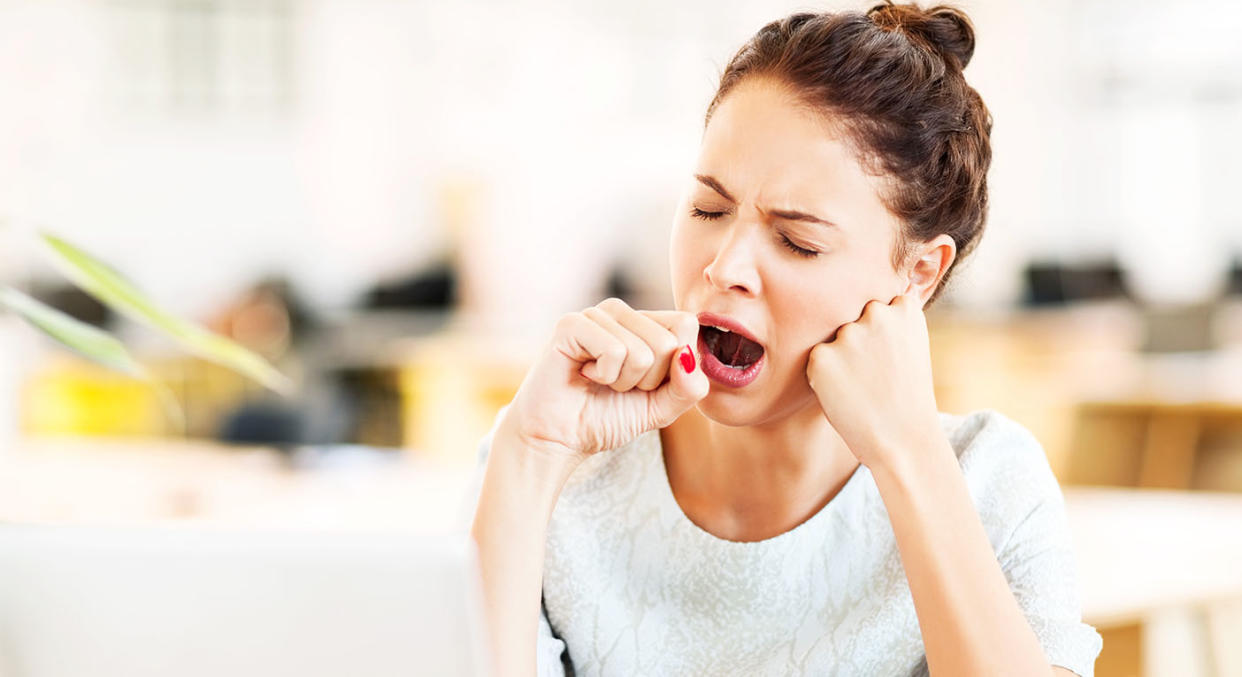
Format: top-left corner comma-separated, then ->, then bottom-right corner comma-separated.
699,77 -> 889,227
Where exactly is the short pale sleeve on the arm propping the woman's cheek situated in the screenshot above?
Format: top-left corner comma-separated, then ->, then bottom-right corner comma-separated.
997,424 -> 1104,677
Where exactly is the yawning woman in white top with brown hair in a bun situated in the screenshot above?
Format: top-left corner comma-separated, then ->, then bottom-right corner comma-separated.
472,4 -> 1102,676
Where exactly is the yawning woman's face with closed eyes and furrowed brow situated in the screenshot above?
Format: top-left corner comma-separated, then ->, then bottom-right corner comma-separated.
669,77 -> 908,425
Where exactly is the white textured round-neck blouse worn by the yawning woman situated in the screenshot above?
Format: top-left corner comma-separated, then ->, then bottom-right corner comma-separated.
476,405 -> 1103,677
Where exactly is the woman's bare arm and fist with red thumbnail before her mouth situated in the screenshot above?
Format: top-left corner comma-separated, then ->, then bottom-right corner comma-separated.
471,298 -> 710,677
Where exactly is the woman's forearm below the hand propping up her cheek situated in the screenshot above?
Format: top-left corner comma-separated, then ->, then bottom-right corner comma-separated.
873,437 -> 1049,676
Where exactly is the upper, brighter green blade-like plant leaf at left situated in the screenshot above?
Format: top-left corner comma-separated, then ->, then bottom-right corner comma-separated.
40,232 -> 293,395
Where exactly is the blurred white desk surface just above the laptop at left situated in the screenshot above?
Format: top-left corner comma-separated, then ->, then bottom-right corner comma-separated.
0,437 -> 474,534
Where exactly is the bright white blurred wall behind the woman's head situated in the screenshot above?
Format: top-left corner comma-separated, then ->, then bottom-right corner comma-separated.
0,0 -> 1242,324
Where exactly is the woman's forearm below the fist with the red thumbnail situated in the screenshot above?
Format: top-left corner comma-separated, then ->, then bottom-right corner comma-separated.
471,424 -> 575,676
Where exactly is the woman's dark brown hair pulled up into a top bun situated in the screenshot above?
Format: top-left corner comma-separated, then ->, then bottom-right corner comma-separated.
703,1 -> 992,304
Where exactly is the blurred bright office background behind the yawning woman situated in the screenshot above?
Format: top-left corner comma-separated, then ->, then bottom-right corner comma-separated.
0,0 -> 1242,676
